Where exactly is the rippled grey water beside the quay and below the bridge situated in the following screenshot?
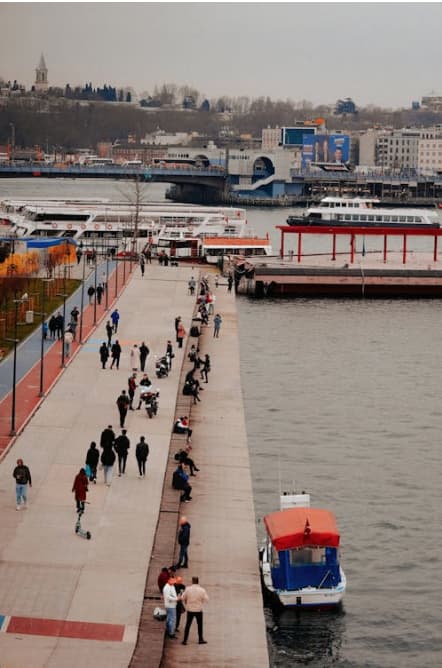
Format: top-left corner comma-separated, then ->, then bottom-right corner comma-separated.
0,180 -> 442,668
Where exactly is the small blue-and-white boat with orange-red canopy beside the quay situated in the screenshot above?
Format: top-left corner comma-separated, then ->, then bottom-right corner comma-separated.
260,492 -> 346,608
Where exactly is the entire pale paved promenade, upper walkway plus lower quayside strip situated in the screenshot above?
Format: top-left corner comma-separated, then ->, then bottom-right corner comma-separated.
0,264 -> 268,668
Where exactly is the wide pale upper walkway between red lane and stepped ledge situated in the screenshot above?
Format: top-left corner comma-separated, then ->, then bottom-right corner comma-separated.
0,265 -> 194,668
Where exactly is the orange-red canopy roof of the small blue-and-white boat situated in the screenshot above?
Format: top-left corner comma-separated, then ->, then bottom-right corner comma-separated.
264,508 -> 339,552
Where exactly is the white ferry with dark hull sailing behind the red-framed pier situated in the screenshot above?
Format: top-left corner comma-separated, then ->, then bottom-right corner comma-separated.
287,197 -> 440,228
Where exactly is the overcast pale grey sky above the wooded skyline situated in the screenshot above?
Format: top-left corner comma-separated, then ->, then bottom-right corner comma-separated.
0,2 -> 442,107
